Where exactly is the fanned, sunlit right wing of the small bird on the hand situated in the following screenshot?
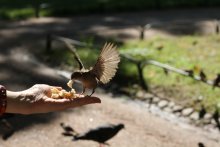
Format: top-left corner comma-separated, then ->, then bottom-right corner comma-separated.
91,43 -> 120,84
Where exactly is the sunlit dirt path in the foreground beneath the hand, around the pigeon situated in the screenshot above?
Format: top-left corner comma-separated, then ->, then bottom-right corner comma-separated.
0,94 -> 220,147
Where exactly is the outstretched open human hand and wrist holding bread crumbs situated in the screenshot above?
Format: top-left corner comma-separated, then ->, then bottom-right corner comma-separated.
6,84 -> 101,114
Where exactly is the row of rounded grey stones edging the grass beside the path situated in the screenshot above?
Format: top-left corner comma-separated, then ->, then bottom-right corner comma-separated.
135,91 -> 220,131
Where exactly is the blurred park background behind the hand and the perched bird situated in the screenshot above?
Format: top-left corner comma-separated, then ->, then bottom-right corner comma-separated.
0,0 -> 220,147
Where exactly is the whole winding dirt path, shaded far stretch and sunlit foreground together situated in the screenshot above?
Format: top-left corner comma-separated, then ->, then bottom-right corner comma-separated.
0,9 -> 220,147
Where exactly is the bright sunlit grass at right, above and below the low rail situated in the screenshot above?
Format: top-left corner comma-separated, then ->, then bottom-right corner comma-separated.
120,35 -> 220,109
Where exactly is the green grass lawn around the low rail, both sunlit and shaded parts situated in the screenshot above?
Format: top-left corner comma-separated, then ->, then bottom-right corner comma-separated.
46,35 -> 220,111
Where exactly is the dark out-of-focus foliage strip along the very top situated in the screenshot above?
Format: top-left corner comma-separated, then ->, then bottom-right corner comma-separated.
0,0 -> 220,19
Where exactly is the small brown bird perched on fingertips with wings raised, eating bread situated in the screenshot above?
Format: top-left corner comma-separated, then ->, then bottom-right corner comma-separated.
71,43 -> 120,96
